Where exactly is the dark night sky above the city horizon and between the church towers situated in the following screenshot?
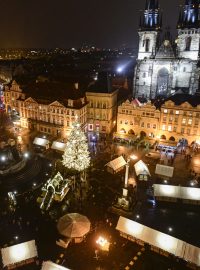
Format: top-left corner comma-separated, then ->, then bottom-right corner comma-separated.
0,0 -> 184,48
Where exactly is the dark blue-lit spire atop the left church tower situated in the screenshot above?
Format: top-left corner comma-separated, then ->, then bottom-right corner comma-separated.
140,0 -> 161,31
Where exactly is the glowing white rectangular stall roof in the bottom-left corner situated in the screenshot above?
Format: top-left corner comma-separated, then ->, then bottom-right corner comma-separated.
1,240 -> 38,267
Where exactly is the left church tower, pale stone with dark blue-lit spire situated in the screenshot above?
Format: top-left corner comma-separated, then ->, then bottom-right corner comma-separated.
138,0 -> 162,60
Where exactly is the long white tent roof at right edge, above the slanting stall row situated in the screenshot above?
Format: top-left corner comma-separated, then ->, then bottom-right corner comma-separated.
153,184 -> 200,201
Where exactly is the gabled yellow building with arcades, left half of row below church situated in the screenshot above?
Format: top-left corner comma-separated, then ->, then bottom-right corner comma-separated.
117,99 -> 160,138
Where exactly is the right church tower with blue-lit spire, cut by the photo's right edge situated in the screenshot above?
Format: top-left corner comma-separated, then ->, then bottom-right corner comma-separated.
177,0 -> 200,60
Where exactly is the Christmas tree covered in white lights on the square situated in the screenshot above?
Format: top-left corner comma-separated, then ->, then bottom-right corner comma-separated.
62,118 -> 90,172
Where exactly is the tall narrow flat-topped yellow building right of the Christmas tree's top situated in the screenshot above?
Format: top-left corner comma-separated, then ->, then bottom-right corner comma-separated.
86,84 -> 118,134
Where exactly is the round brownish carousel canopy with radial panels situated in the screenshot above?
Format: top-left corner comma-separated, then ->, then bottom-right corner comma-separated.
57,213 -> 90,238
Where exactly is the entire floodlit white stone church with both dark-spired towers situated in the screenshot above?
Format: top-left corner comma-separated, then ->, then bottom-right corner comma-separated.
133,0 -> 200,99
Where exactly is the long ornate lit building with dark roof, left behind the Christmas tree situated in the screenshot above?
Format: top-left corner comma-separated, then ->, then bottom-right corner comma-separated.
5,82 -> 87,138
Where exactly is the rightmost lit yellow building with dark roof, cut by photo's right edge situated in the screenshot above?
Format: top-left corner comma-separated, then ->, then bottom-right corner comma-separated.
158,94 -> 200,143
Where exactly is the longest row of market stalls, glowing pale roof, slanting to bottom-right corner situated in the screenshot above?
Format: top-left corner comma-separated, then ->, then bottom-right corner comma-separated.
116,217 -> 200,269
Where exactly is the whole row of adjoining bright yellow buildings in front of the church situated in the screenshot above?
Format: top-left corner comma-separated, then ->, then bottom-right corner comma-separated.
117,94 -> 200,143
